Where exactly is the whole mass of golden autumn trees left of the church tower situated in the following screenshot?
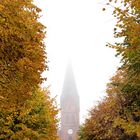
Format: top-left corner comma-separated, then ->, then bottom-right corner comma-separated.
0,0 -> 58,140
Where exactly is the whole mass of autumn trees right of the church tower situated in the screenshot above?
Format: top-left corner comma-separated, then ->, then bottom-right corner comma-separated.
79,0 -> 140,140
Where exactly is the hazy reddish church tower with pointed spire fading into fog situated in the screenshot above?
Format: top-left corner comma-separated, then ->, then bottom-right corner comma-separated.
60,64 -> 80,140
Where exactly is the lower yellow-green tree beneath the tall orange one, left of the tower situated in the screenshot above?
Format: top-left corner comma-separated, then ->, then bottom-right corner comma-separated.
0,89 -> 58,140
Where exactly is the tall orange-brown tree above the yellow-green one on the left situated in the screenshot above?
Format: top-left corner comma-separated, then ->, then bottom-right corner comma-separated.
0,0 -> 46,108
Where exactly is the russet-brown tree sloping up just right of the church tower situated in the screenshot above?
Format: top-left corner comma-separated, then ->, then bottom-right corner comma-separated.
79,70 -> 138,140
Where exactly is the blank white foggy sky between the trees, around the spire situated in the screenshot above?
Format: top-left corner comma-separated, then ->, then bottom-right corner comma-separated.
36,0 -> 119,121
